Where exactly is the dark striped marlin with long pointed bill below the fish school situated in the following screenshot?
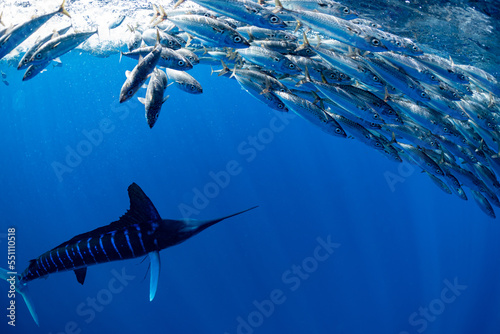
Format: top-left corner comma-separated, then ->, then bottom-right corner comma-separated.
0,183 -> 256,325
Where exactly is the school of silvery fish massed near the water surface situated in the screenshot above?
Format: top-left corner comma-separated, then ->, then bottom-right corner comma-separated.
0,0 -> 500,218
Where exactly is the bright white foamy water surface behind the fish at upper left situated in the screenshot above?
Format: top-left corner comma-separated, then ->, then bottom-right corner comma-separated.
0,0 -> 197,62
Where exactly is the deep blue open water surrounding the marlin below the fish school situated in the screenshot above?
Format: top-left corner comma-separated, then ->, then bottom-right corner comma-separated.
0,1 -> 500,334
